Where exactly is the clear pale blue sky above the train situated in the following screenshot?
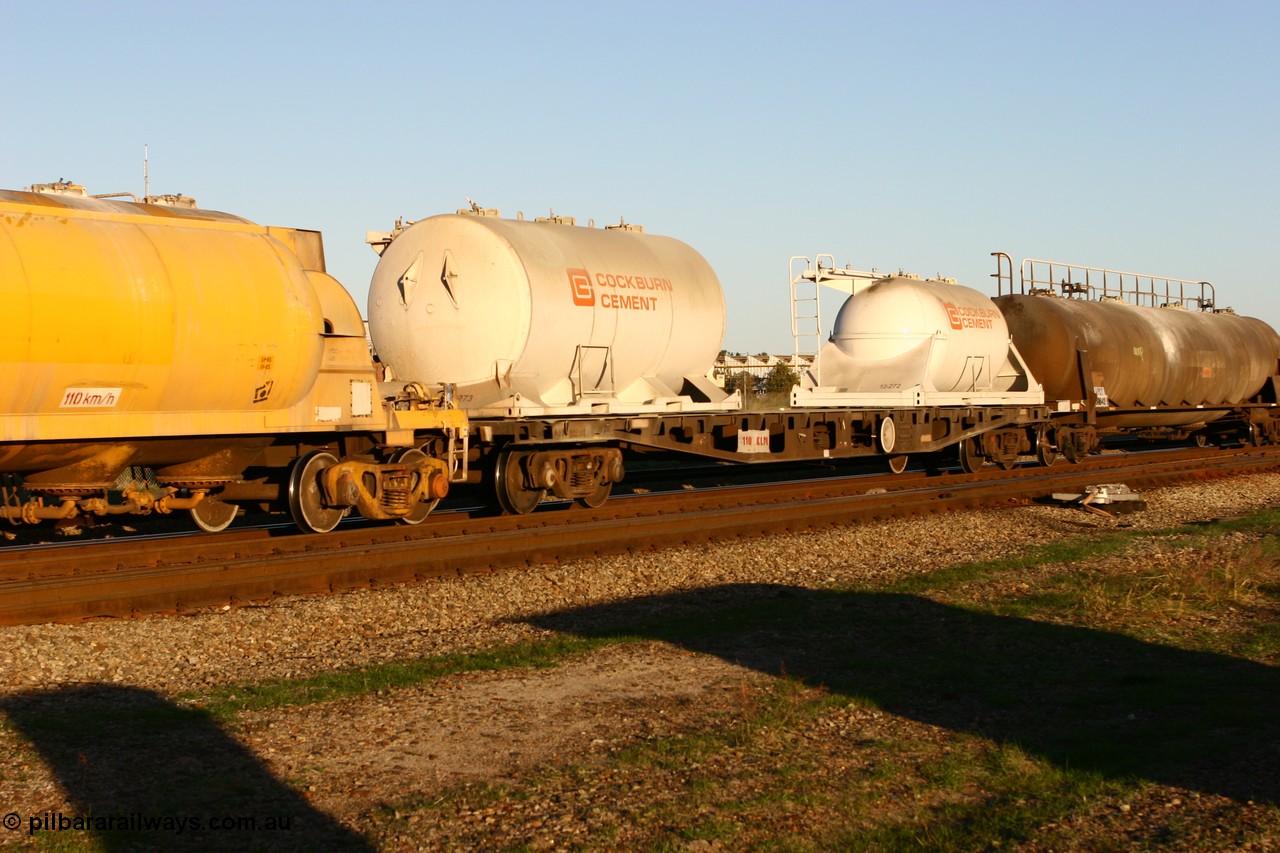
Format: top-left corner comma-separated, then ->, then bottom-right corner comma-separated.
0,0 -> 1280,352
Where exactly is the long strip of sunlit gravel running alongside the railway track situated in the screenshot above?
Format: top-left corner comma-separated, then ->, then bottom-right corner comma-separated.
10,474 -> 1280,695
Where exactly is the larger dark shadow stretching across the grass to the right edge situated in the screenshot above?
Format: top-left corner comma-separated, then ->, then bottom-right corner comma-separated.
531,585 -> 1280,803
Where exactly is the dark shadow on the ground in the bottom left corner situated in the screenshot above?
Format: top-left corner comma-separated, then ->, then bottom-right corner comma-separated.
0,684 -> 372,850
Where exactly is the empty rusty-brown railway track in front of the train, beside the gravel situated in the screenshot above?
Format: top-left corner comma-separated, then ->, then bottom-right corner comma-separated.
0,447 -> 1280,625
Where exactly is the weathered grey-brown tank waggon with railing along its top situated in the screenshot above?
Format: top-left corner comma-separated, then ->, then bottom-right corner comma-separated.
995,254 -> 1280,460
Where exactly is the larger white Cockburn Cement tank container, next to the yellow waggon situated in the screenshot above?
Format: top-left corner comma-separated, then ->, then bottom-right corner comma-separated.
369,213 -> 737,416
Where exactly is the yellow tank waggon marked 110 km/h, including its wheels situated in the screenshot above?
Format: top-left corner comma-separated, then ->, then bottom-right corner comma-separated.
0,182 -> 467,532
